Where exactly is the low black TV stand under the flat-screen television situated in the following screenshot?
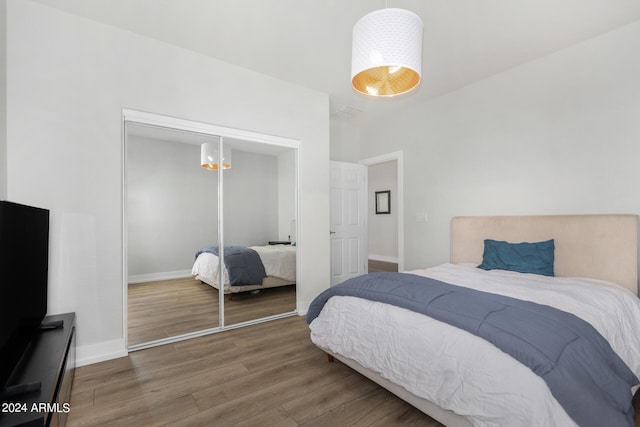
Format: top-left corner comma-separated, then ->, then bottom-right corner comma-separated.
0,313 -> 76,427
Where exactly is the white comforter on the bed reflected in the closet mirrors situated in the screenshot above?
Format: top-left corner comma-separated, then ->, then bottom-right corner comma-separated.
191,245 -> 296,285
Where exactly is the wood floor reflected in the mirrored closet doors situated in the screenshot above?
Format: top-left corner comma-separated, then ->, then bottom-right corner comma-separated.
128,277 -> 296,345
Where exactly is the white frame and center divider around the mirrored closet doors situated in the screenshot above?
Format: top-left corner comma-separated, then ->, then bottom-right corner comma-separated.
121,108 -> 300,352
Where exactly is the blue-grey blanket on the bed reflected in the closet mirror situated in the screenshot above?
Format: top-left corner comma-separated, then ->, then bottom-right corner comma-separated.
196,246 -> 267,286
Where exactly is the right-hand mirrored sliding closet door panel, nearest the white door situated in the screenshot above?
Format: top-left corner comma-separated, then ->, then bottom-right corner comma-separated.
223,142 -> 297,326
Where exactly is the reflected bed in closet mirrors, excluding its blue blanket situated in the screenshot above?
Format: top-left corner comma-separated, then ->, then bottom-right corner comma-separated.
191,245 -> 296,295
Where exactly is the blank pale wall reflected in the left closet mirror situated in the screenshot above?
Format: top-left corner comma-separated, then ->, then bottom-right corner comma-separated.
126,135 -> 218,282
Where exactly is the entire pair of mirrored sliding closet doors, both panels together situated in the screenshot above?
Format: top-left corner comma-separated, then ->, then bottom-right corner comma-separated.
123,110 -> 299,350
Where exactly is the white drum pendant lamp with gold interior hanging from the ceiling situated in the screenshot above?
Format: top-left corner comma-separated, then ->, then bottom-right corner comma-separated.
351,8 -> 423,97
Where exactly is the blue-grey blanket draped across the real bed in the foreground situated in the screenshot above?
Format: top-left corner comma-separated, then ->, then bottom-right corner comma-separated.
307,273 -> 638,427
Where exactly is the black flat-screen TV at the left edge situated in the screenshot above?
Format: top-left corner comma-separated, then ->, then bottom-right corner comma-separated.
0,201 -> 49,390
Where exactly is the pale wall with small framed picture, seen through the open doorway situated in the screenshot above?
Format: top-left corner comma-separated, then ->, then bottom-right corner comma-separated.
367,161 -> 398,262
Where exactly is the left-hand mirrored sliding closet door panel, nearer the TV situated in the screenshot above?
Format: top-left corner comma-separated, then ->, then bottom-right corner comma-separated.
124,122 -> 221,348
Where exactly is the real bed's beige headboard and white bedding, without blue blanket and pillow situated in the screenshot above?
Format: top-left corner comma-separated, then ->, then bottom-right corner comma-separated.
307,215 -> 640,426
